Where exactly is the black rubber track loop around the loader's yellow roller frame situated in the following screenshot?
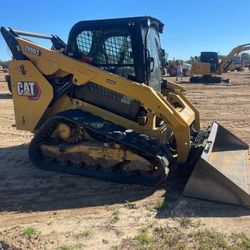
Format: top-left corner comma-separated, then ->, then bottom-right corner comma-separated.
29,110 -> 171,186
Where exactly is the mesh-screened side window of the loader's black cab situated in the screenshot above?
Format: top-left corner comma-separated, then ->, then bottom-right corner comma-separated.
76,29 -> 135,78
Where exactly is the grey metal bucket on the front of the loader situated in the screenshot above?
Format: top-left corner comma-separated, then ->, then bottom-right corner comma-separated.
183,122 -> 250,207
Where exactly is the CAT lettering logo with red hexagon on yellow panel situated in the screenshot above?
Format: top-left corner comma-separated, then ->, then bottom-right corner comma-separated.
17,82 -> 41,100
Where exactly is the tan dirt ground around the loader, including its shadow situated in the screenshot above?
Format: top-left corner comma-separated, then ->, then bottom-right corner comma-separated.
0,71 -> 250,249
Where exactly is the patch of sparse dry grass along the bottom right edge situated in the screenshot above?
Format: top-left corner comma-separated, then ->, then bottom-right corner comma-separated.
117,221 -> 250,250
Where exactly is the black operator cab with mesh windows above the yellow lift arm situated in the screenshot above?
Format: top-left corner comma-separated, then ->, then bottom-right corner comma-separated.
66,16 -> 163,91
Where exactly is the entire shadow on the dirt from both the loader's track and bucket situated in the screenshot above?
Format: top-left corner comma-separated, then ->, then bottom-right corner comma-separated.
0,144 -> 250,218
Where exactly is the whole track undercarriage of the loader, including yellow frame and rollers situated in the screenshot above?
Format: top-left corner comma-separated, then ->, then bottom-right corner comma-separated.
29,110 -> 170,185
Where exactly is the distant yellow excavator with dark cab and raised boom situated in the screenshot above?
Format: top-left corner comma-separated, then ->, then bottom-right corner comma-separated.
190,43 -> 250,83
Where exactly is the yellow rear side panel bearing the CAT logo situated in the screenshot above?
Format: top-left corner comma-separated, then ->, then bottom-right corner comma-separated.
8,60 -> 53,131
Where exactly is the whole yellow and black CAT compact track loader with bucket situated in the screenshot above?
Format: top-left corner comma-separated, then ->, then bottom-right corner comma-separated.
1,17 -> 250,206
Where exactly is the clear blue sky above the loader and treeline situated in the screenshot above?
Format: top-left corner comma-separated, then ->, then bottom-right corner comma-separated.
0,0 -> 250,60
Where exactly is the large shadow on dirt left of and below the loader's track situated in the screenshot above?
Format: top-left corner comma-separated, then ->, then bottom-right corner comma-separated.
0,144 -> 156,212
